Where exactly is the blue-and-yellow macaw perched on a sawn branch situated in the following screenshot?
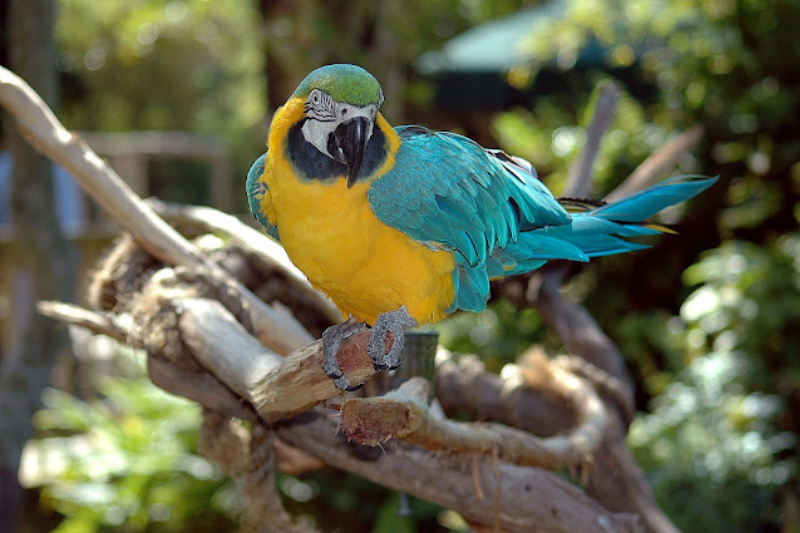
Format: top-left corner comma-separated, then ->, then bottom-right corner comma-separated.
247,65 -> 715,389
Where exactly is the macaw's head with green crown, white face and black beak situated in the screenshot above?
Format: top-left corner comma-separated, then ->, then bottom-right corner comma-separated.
292,65 -> 383,187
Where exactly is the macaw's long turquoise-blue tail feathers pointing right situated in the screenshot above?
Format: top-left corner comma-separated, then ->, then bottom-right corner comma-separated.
487,176 -> 717,278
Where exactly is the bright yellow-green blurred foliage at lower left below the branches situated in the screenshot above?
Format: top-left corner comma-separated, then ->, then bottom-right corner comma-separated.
23,368 -> 238,533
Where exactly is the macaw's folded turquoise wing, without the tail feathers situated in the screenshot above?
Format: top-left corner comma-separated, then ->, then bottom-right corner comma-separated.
369,126 -> 570,267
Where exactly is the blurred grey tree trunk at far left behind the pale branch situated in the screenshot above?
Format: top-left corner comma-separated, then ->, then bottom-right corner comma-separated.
0,0 -> 75,531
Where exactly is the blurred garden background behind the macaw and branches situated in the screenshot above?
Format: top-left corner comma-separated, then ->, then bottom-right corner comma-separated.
0,0 -> 800,533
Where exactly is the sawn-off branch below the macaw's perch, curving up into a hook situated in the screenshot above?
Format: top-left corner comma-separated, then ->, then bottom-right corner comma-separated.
341,369 -> 608,469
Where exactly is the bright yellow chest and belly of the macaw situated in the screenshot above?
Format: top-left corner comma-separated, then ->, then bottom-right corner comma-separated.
267,151 -> 454,324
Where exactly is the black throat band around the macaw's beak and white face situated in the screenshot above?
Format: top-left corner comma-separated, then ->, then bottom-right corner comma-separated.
286,118 -> 386,181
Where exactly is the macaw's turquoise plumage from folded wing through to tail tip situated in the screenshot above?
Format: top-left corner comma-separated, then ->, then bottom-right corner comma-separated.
369,126 -> 716,311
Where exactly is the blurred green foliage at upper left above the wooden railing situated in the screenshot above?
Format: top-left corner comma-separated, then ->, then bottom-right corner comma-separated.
57,0 -> 266,191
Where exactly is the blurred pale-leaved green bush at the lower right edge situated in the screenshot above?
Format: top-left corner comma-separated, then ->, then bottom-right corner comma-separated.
630,233 -> 800,532
